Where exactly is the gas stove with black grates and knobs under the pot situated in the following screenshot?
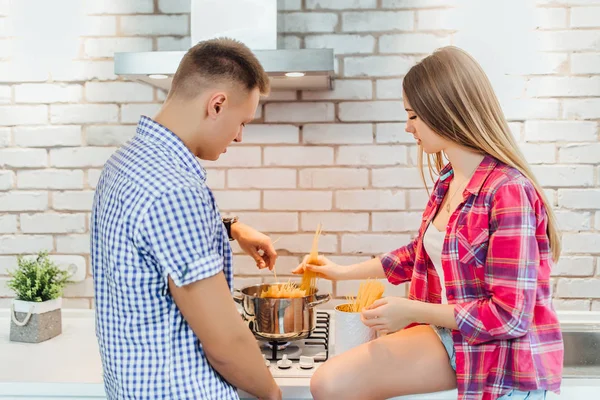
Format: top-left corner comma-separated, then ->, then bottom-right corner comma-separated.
258,311 -> 333,378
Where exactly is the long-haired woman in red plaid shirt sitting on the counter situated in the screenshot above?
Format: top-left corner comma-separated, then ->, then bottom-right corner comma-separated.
295,47 -> 563,400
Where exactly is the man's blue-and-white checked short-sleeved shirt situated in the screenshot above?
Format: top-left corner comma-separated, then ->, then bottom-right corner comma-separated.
91,117 -> 237,399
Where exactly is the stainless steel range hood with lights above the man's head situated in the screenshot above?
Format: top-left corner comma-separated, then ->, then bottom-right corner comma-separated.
114,0 -> 334,90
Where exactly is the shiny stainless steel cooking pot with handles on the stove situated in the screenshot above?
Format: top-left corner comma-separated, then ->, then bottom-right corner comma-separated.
233,283 -> 331,342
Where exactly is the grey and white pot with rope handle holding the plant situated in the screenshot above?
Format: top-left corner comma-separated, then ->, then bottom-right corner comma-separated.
10,299 -> 62,343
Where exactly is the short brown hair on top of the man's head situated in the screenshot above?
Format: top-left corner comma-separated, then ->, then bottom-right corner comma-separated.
169,38 -> 270,98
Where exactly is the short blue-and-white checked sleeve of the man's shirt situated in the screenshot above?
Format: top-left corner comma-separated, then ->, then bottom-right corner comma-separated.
139,187 -> 223,286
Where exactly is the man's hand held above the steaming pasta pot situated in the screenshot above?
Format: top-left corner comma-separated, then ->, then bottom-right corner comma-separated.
231,222 -> 277,269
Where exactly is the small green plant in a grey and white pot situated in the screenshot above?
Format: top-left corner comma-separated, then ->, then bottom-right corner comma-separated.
8,251 -> 69,343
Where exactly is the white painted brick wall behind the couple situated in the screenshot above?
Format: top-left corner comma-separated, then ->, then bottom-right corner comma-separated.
0,0 -> 600,310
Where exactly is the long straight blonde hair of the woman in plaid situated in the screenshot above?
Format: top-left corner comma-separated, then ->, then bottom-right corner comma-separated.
402,46 -> 561,262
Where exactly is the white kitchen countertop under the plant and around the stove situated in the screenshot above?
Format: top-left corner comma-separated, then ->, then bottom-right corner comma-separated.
0,310 -> 600,400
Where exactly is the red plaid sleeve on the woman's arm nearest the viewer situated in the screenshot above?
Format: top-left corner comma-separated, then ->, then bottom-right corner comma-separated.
454,181 -> 540,345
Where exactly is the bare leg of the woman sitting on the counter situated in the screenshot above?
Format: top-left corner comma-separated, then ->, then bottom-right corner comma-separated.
310,326 -> 456,400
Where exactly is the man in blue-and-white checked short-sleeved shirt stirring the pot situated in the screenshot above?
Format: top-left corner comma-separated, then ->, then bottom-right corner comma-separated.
91,39 -> 281,400
